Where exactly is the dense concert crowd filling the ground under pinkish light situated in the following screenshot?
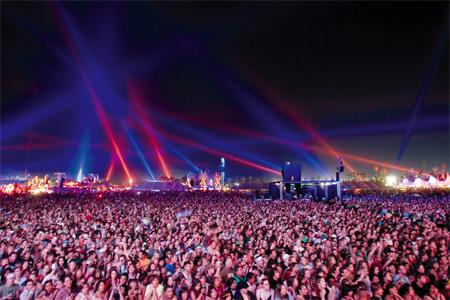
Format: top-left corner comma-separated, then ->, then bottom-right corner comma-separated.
0,192 -> 450,300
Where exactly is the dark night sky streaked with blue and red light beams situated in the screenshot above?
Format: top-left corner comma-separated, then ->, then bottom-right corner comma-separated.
0,1 -> 450,178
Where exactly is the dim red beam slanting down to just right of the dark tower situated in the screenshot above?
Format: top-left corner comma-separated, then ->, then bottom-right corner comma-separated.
232,58 -> 355,172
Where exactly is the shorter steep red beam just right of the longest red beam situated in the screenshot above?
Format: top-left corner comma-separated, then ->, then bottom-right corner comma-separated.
127,81 -> 172,178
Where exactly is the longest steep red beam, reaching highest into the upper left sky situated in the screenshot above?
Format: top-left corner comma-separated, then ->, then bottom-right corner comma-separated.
51,7 -> 133,184
